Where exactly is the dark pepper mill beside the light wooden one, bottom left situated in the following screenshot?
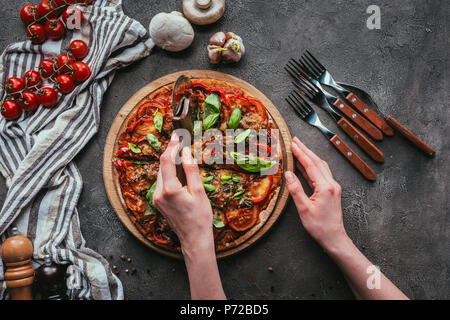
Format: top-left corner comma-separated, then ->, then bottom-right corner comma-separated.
36,254 -> 68,300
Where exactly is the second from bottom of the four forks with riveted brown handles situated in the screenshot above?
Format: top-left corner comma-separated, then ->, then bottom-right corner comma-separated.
286,65 -> 384,162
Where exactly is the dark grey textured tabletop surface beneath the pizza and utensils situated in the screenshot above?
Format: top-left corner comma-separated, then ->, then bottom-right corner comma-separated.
0,0 -> 450,299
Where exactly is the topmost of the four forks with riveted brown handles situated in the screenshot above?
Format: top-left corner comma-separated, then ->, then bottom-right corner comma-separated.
299,50 -> 394,136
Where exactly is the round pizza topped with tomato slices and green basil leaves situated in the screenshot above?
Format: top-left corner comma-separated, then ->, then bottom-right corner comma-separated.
112,79 -> 283,252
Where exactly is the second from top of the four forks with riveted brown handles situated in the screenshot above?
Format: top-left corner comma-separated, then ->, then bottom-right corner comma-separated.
285,59 -> 383,140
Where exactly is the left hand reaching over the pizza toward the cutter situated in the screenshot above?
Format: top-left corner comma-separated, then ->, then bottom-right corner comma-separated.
153,133 -> 214,251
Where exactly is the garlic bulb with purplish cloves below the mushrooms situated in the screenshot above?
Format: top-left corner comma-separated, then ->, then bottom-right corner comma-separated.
208,32 -> 245,64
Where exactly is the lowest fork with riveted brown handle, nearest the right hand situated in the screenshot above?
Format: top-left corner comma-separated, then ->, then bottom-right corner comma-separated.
286,91 -> 377,181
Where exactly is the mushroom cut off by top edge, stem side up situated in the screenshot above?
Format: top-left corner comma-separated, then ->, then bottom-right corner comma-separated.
183,0 -> 225,25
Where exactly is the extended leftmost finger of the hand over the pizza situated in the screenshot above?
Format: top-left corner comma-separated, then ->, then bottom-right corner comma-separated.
159,133 -> 182,193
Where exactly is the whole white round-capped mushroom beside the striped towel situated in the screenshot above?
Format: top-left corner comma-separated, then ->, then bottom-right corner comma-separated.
149,11 -> 194,51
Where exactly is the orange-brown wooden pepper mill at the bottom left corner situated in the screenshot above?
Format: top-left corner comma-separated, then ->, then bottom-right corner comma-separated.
1,227 -> 34,300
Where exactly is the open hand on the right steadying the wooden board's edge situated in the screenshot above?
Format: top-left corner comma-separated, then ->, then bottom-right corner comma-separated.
285,138 -> 347,250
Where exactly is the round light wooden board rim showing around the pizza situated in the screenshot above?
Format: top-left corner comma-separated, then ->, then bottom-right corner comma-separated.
103,70 -> 294,259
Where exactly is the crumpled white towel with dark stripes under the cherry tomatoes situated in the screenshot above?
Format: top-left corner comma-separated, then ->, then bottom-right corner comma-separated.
0,0 -> 153,299
